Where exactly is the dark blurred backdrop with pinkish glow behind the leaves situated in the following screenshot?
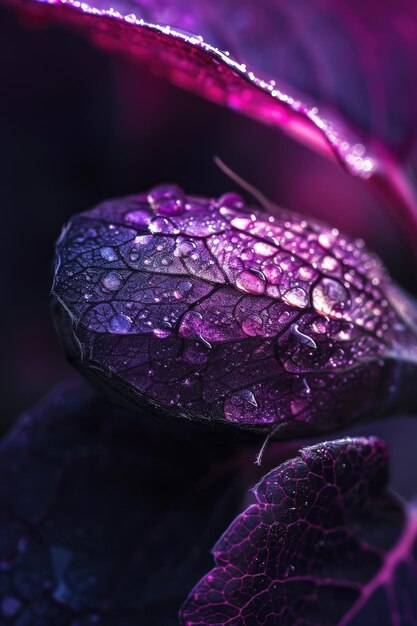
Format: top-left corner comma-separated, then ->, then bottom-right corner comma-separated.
0,8 -> 417,492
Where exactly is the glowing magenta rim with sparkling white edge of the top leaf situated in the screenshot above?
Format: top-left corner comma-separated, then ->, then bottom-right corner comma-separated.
8,0 -> 417,244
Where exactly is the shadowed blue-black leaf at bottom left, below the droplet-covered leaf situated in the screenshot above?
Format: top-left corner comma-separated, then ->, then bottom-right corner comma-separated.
0,383 -> 248,626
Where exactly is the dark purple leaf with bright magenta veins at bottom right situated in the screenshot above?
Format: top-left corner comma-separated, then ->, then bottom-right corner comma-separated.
182,438 -> 417,626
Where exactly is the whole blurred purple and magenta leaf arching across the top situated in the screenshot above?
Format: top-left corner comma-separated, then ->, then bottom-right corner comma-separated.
9,0 -> 417,237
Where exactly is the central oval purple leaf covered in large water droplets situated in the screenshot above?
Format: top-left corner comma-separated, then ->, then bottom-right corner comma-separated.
53,186 -> 417,437
